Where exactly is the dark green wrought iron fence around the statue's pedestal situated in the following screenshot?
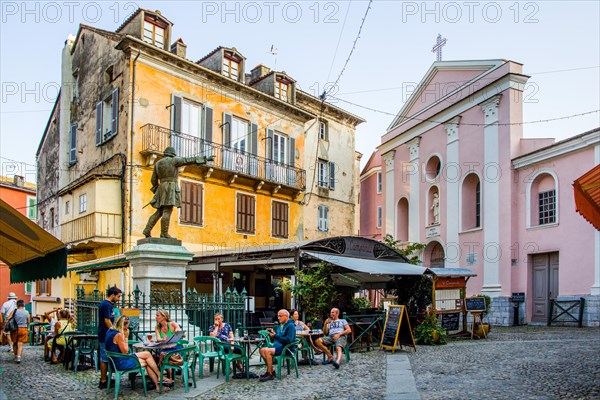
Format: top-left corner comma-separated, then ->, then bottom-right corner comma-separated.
75,287 -> 248,339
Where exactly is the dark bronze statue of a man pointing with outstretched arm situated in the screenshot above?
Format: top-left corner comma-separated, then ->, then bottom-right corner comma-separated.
142,146 -> 214,238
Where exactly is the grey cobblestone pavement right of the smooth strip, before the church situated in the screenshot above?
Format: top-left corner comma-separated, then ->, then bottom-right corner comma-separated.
409,326 -> 600,400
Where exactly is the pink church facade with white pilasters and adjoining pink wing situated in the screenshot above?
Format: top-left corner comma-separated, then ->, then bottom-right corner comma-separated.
360,60 -> 600,325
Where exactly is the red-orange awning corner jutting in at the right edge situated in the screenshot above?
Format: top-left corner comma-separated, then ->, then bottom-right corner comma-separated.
573,165 -> 600,231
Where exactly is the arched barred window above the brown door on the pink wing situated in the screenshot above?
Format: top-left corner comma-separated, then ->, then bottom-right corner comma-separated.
527,171 -> 558,227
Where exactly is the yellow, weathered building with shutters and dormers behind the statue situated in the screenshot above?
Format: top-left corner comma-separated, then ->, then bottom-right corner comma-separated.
37,9 -> 363,310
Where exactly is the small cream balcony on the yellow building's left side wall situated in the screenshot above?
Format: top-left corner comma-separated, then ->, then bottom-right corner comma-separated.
60,212 -> 122,244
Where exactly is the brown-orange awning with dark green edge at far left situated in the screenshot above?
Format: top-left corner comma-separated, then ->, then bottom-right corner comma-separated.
0,199 -> 67,283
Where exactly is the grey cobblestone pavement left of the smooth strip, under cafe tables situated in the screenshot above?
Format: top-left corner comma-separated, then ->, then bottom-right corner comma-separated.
0,346 -> 386,400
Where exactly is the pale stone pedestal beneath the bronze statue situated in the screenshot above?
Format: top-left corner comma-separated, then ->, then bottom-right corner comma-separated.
125,238 -> 193,330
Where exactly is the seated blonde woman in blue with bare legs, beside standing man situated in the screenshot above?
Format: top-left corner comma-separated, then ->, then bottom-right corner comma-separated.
105,315 -> 173,392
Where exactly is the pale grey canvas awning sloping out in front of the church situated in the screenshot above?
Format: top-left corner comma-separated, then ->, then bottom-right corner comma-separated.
302,251 -> 427,289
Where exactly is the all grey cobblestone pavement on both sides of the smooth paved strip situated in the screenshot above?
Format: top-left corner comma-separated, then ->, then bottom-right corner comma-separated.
0,326 -> 600,400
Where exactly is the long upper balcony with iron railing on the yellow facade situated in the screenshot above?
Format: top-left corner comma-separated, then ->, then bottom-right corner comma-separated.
141,124 -> 306,192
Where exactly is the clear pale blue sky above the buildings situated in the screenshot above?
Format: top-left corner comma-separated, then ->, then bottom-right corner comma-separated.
0,0 -> 600,178
